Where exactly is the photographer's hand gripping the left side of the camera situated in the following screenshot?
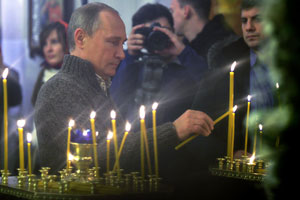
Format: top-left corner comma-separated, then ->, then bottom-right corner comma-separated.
127,24 -> 145,55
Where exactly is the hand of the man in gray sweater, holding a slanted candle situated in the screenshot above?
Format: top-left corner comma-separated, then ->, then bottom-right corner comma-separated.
173,110 -> 214,140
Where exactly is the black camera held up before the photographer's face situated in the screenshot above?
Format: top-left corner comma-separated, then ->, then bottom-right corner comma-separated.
135,22 -> 172,53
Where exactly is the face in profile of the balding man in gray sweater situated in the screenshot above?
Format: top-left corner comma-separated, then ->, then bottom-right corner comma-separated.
84,11 -> 126,79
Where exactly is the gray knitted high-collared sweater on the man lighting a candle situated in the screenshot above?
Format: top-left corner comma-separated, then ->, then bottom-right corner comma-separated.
34,55 -> 178,173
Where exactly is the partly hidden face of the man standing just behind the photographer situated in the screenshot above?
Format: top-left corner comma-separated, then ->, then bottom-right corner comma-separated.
170,0 -> 184,35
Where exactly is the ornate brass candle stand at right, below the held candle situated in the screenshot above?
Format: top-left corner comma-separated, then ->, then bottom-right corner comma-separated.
210,157 -> 266,182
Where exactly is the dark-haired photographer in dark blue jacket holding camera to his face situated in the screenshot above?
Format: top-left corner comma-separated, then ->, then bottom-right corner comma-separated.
110,4 -> 207,131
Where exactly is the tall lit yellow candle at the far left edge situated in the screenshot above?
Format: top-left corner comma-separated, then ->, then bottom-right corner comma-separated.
0,68 -> 9,173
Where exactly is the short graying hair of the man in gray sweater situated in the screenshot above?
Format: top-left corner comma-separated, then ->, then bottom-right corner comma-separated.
67,2 -> 118,52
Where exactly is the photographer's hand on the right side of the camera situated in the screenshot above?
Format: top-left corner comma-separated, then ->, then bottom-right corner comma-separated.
154,26 -> 185,57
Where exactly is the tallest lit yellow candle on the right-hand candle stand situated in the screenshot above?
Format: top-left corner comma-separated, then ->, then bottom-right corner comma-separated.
227,61 -> 236,156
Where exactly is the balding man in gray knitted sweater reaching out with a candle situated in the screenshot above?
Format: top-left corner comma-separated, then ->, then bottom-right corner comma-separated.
34,3 -> 213,178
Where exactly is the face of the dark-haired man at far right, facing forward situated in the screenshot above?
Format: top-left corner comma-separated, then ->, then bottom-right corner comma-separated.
241,8 -> 264,49
